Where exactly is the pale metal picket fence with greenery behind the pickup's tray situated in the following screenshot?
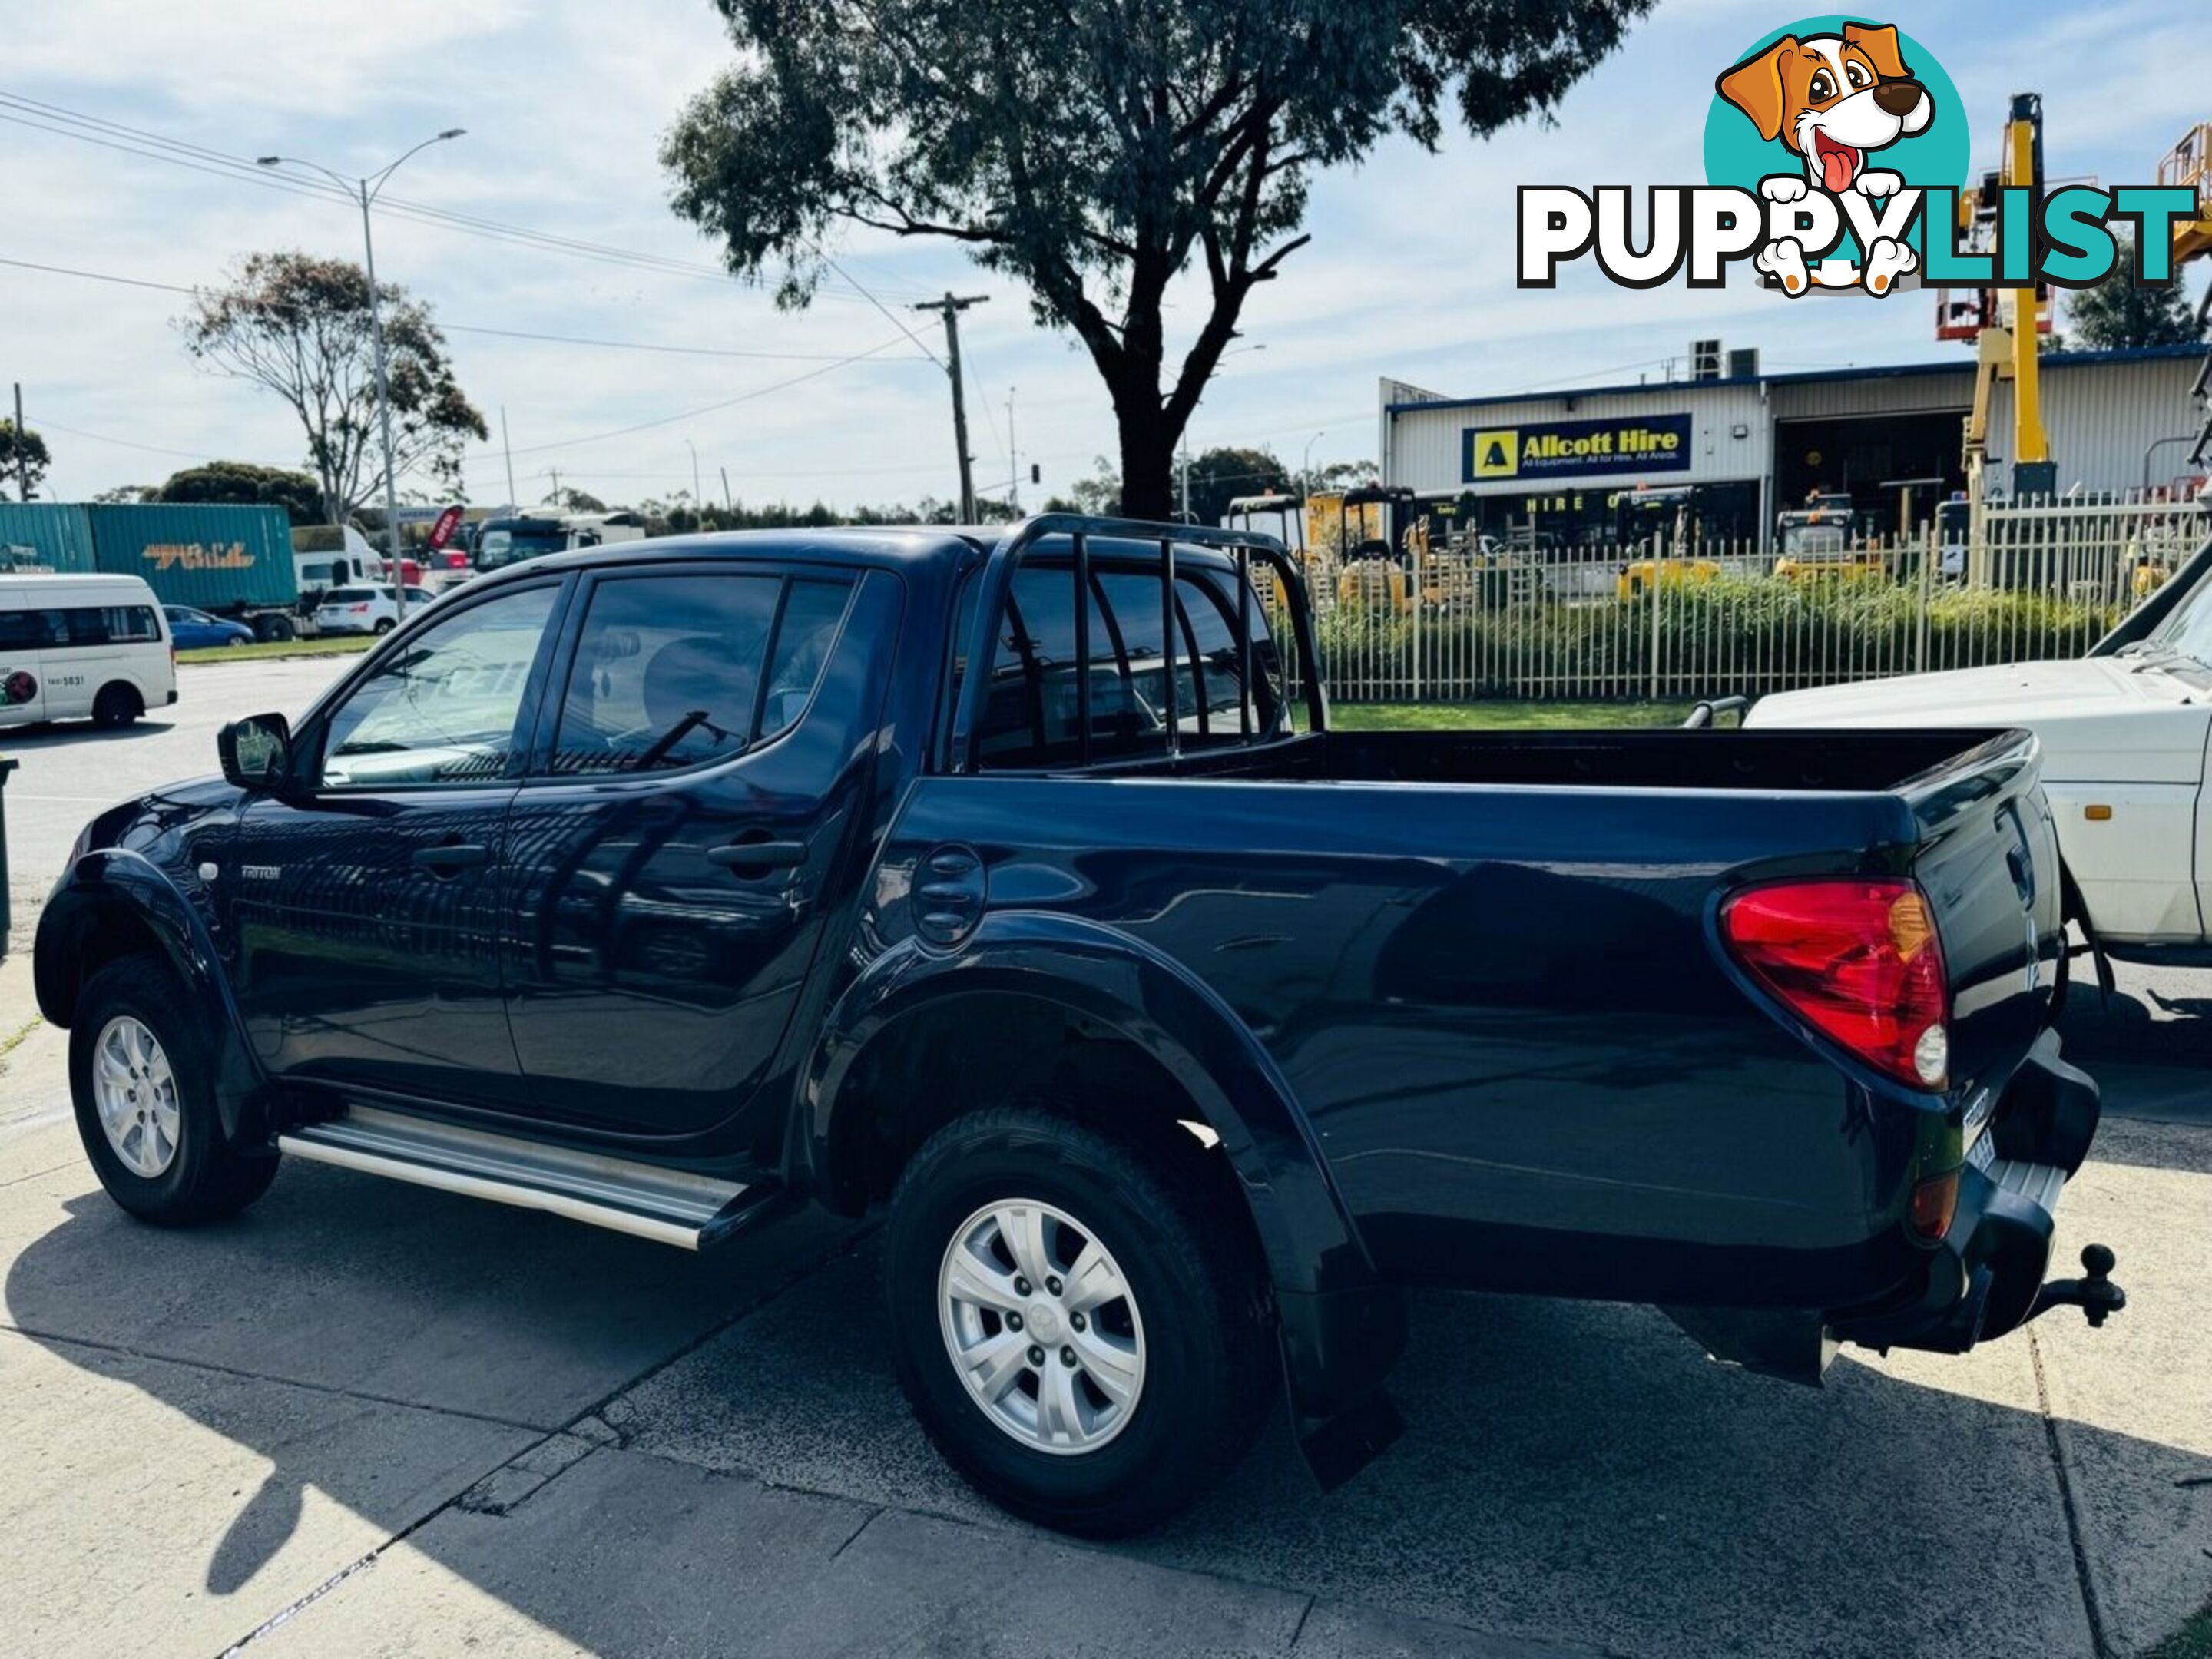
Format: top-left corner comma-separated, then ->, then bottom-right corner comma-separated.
1303,495 -> 2212,701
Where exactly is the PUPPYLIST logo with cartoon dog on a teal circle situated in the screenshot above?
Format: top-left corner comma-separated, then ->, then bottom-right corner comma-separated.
1518,15 -> 2197,299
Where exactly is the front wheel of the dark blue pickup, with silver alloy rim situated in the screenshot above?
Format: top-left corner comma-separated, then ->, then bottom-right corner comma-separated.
68,955 -> 276,1226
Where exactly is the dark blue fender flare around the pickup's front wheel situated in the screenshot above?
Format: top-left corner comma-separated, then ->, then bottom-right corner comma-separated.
31,847 -> 267,1144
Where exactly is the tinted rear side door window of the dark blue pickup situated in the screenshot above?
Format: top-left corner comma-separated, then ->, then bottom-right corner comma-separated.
553,573 -> 852,774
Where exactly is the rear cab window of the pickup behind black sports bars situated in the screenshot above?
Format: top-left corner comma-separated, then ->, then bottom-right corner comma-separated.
955,566 -> 1283,767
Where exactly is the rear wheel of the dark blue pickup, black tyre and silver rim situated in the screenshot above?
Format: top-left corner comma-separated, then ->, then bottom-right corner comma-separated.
885,1108 -> 1277,1538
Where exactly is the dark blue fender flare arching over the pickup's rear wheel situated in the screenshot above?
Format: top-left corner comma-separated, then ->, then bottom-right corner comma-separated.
796,912 -> 1376,1294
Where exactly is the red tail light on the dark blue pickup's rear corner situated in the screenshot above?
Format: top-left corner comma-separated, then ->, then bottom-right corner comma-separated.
1721,878 -> 1951,1088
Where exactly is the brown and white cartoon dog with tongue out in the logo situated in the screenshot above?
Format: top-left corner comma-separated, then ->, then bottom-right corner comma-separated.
1714,22 -> 1936,294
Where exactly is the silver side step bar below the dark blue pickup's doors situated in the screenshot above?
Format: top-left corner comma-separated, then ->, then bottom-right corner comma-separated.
276,1106 -> 781,1250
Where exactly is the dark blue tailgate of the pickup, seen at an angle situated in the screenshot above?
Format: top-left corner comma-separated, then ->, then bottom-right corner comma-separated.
1898,732 -> 2066,1110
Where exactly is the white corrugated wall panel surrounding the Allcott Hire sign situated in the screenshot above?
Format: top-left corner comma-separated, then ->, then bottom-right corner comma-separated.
1382,382 -> 1770,495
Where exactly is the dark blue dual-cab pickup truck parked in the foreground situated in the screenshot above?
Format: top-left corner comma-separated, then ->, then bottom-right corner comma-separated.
33,515 -> 2124,1535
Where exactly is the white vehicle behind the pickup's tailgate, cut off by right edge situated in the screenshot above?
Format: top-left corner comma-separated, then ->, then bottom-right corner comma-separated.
1743,573 -> 2212,960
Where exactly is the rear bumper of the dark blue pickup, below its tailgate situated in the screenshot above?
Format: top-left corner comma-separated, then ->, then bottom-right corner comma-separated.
1830,1031 -> 2099,1354
